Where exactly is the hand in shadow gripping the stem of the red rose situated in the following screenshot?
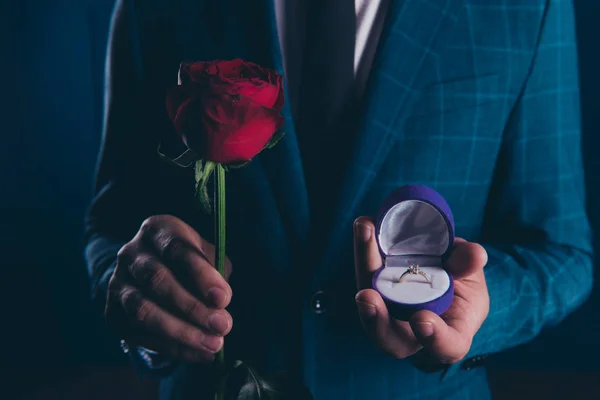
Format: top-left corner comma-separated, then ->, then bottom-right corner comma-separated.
105,215 -> 233,362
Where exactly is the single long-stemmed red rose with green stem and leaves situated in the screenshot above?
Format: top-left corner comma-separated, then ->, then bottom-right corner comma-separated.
159,59 -> 296,400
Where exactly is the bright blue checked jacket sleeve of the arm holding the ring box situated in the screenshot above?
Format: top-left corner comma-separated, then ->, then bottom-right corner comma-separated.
442,0 -> 593,374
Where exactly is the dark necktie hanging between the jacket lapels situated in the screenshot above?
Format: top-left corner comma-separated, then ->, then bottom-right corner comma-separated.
295,0 -> 356,239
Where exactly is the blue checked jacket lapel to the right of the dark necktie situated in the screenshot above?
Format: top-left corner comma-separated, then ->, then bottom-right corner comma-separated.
315,0 -> 463,281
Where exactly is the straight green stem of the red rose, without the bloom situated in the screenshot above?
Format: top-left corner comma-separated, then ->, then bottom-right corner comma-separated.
214,164 -> 226,400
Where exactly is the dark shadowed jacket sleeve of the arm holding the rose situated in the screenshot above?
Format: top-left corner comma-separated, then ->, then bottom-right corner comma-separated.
85,0 -> 195,376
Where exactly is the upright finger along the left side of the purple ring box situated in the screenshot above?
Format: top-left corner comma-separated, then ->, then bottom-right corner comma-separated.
354,217 -> 382,290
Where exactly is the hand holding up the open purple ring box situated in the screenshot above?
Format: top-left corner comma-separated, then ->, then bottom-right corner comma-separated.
354,217 -> 489,364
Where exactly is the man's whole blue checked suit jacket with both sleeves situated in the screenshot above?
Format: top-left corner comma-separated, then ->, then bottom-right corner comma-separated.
87,0 -> 592,400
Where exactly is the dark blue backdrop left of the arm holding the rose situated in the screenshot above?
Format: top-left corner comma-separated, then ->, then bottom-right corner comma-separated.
0,0 -> 124,398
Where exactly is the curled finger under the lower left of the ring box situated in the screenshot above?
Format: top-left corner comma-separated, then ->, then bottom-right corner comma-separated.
356,289 -> 421,358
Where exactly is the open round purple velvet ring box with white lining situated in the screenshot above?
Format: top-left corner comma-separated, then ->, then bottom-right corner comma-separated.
373,185 -> 454,321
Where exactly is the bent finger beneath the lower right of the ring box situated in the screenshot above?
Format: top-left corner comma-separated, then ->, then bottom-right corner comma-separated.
410,311 -> 476,364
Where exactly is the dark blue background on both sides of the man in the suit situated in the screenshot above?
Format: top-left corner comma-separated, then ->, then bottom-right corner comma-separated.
0,0 -> 600,400
